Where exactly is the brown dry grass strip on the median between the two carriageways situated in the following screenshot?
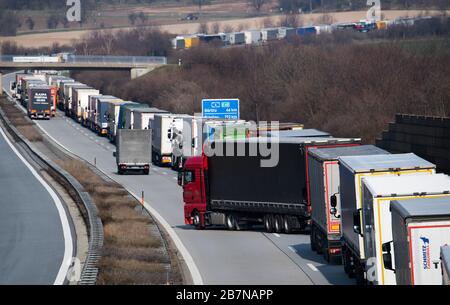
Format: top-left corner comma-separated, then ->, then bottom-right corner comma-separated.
57,160 -> 181,285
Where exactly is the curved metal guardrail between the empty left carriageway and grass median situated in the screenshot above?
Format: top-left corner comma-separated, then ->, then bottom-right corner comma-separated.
0,95 -> 104,285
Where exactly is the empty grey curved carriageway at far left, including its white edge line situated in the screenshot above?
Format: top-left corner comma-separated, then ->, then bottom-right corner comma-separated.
0,98 -> 73,285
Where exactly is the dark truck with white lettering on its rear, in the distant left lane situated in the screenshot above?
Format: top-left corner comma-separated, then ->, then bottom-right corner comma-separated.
27,85 -> 53,120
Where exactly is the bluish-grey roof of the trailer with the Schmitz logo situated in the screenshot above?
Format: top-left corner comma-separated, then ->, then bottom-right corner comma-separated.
390,197 -> 450,219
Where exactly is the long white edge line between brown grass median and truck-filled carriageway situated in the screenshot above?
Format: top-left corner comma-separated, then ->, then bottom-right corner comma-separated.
36,124 -> 203,285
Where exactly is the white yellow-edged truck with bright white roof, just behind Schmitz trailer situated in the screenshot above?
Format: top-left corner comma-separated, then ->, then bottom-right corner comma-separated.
362,174 -> 450,285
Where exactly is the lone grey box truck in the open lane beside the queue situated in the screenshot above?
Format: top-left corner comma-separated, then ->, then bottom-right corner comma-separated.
115,129 -> 152,175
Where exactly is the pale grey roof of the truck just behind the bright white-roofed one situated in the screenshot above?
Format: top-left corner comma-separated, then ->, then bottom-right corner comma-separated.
339,153 -> 436,173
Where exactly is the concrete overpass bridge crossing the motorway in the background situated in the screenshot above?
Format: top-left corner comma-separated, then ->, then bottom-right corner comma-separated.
0,55 -> 167,92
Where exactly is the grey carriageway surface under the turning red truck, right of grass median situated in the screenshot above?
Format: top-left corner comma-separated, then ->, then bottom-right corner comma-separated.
3,75 -> 354,285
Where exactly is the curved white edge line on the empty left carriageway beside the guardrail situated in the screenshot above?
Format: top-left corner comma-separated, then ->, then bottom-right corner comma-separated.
0,124 -> 73,285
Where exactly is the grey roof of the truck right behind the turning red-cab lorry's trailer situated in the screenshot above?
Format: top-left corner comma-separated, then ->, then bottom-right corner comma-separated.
309,145 -> 389,161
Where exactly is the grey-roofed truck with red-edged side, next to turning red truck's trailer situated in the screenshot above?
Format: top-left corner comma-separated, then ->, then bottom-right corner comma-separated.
308,145 -> 389,264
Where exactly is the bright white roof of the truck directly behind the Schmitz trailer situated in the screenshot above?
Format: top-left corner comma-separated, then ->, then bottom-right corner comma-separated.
362,174 -> 450,197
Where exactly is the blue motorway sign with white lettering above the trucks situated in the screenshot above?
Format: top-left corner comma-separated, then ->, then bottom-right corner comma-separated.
202,99 -> 240,120
